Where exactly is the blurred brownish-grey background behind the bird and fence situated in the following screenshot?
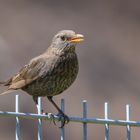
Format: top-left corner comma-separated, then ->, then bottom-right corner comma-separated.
0,0 -> 140,140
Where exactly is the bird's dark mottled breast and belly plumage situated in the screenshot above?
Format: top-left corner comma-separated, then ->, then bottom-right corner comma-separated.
24,53 -> 78,96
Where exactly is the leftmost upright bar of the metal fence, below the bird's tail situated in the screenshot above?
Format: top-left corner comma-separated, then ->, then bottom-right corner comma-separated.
15,95 -> 20,140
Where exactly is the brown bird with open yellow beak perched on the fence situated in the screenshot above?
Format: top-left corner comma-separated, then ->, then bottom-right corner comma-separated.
0,30 -> 84,128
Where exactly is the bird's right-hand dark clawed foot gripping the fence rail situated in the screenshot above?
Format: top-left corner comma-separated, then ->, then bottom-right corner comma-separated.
57,113 -> 70,128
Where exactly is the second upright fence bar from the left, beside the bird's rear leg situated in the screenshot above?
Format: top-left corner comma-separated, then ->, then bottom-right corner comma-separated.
37,97 -> 43,140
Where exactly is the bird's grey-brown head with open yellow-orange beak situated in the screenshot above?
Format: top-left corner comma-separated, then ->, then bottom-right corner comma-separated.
51,30 -> 84,51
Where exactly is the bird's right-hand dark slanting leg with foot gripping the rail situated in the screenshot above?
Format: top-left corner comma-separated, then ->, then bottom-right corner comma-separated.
47,96 -> 69,128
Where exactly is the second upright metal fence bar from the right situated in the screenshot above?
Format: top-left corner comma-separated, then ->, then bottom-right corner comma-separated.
104,102 -> 109,140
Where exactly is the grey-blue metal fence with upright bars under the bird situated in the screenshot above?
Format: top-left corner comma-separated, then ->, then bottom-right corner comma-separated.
0,95 -> 140,140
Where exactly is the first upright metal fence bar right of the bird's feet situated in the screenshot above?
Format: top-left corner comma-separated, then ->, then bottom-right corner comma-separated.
83,100 -> 88,140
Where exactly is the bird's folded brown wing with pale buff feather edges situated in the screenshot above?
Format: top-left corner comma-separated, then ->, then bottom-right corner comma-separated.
5,58 -> 45,89
